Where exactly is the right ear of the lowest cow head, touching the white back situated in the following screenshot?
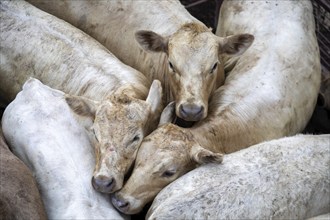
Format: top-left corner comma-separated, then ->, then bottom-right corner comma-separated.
190,144 -> 223,164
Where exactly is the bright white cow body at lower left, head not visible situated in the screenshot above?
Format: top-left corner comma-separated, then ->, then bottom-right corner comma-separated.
2,79 -> 127,219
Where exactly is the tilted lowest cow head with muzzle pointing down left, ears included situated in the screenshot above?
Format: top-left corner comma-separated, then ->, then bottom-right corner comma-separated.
112,103 -> 223,214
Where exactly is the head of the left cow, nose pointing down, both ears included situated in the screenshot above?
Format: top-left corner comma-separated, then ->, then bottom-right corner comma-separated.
66,81 -> 162,193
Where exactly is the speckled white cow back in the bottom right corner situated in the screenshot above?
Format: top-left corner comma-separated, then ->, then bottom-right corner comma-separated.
147,135 -> 330,219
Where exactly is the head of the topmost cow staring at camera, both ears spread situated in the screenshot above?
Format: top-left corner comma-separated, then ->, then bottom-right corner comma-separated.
135,23 -> 254,121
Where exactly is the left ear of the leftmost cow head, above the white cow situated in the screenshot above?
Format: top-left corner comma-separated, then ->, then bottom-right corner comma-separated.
65,94 -> 98,119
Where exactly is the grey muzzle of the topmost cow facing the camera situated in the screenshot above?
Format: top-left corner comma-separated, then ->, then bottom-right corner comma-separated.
179,104 -> 204,121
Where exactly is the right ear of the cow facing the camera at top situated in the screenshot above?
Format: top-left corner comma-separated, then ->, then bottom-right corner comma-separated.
219,34 -> 254,55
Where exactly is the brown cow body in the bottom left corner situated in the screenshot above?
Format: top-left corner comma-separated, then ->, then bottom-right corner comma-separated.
0,127 -> 47,220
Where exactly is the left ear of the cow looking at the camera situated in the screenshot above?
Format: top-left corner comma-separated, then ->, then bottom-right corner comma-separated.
135,30 -> 168,53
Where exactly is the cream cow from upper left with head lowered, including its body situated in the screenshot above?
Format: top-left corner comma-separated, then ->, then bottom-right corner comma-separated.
0,1 -> 163,193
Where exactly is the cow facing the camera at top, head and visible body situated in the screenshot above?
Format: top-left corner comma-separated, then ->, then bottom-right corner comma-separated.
29,0 -> 253,121
